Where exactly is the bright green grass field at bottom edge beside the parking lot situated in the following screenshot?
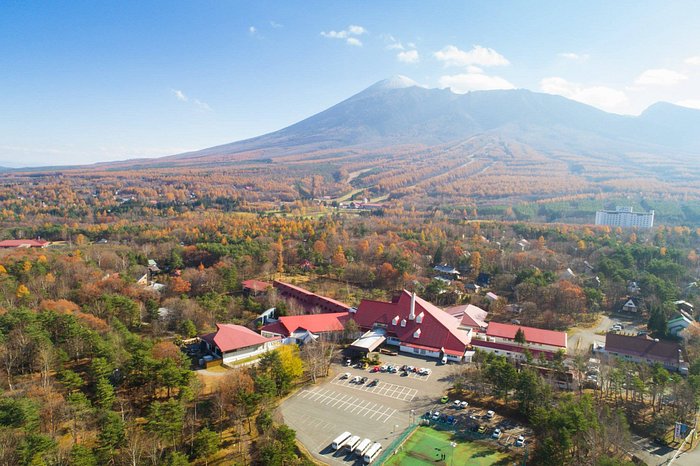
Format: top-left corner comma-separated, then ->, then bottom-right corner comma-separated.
384,427 -> 512,466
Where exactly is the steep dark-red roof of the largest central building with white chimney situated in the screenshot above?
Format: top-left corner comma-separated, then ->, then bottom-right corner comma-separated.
355,290 -> 469,354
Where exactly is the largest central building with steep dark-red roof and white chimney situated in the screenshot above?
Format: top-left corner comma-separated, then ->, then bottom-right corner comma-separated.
351,290 -> 472,361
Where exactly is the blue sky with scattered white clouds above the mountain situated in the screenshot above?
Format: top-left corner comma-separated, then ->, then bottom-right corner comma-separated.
0,0 -> 700,166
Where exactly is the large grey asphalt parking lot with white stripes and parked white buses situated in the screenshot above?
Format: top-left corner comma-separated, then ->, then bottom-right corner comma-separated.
279,355 -> 455,465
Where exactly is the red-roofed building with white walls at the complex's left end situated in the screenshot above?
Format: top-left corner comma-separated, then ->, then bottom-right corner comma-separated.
201,324 -> 282,364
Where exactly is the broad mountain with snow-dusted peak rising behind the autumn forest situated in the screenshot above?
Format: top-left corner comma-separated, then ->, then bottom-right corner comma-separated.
158,76 -> 700,163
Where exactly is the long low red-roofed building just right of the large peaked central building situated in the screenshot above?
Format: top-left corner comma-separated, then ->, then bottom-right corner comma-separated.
472,322 -> 567,359
